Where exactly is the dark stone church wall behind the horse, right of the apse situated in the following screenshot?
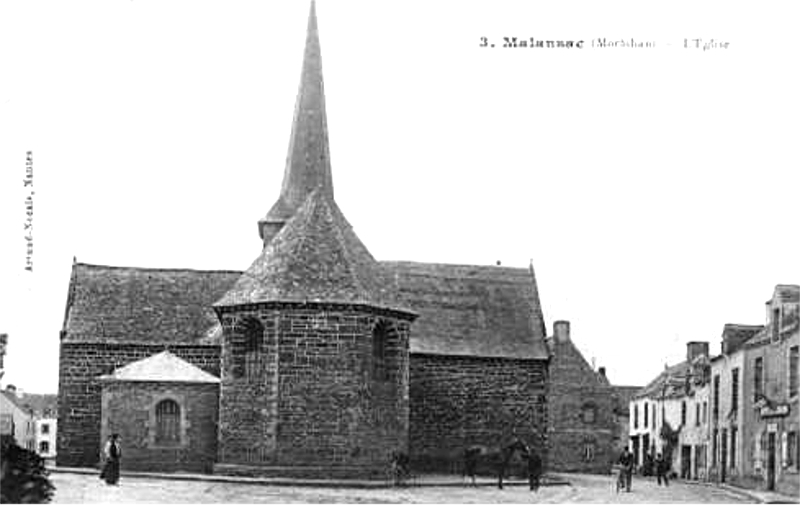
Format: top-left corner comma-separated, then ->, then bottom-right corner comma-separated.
409,354 -> 548,473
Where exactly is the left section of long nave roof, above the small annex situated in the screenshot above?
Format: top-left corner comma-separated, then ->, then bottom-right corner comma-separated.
62,263 -> 241,344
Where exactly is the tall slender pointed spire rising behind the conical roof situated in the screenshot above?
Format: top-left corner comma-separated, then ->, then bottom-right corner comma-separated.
258,0 -> 333,246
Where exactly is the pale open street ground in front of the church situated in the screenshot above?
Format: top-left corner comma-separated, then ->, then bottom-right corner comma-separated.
52,473 -> 753,503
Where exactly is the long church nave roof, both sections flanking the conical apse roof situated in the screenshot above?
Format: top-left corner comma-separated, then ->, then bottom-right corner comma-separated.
64,262 -> 548,359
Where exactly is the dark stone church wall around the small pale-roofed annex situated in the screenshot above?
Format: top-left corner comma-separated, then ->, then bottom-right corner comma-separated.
56,342 -> 219,467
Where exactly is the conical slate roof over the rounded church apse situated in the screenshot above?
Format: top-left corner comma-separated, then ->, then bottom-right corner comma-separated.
214,190 -> 411,315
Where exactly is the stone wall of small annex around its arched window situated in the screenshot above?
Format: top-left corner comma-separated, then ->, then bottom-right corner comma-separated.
100,382 -> 219,473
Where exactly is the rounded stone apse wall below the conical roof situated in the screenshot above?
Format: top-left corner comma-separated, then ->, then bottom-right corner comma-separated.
218,306 -> 409,476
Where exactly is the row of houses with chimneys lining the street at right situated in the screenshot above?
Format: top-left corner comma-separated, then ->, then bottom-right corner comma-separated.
629,285 -> 800,495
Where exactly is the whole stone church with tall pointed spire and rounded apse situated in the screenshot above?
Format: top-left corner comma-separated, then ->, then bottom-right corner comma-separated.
57,3 -> 549,477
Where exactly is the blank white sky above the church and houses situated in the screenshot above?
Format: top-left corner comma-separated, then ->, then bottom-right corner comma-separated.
0,0 -> 800,392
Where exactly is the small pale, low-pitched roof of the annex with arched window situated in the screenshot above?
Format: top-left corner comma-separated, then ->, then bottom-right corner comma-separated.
99,351 -> 219,384
